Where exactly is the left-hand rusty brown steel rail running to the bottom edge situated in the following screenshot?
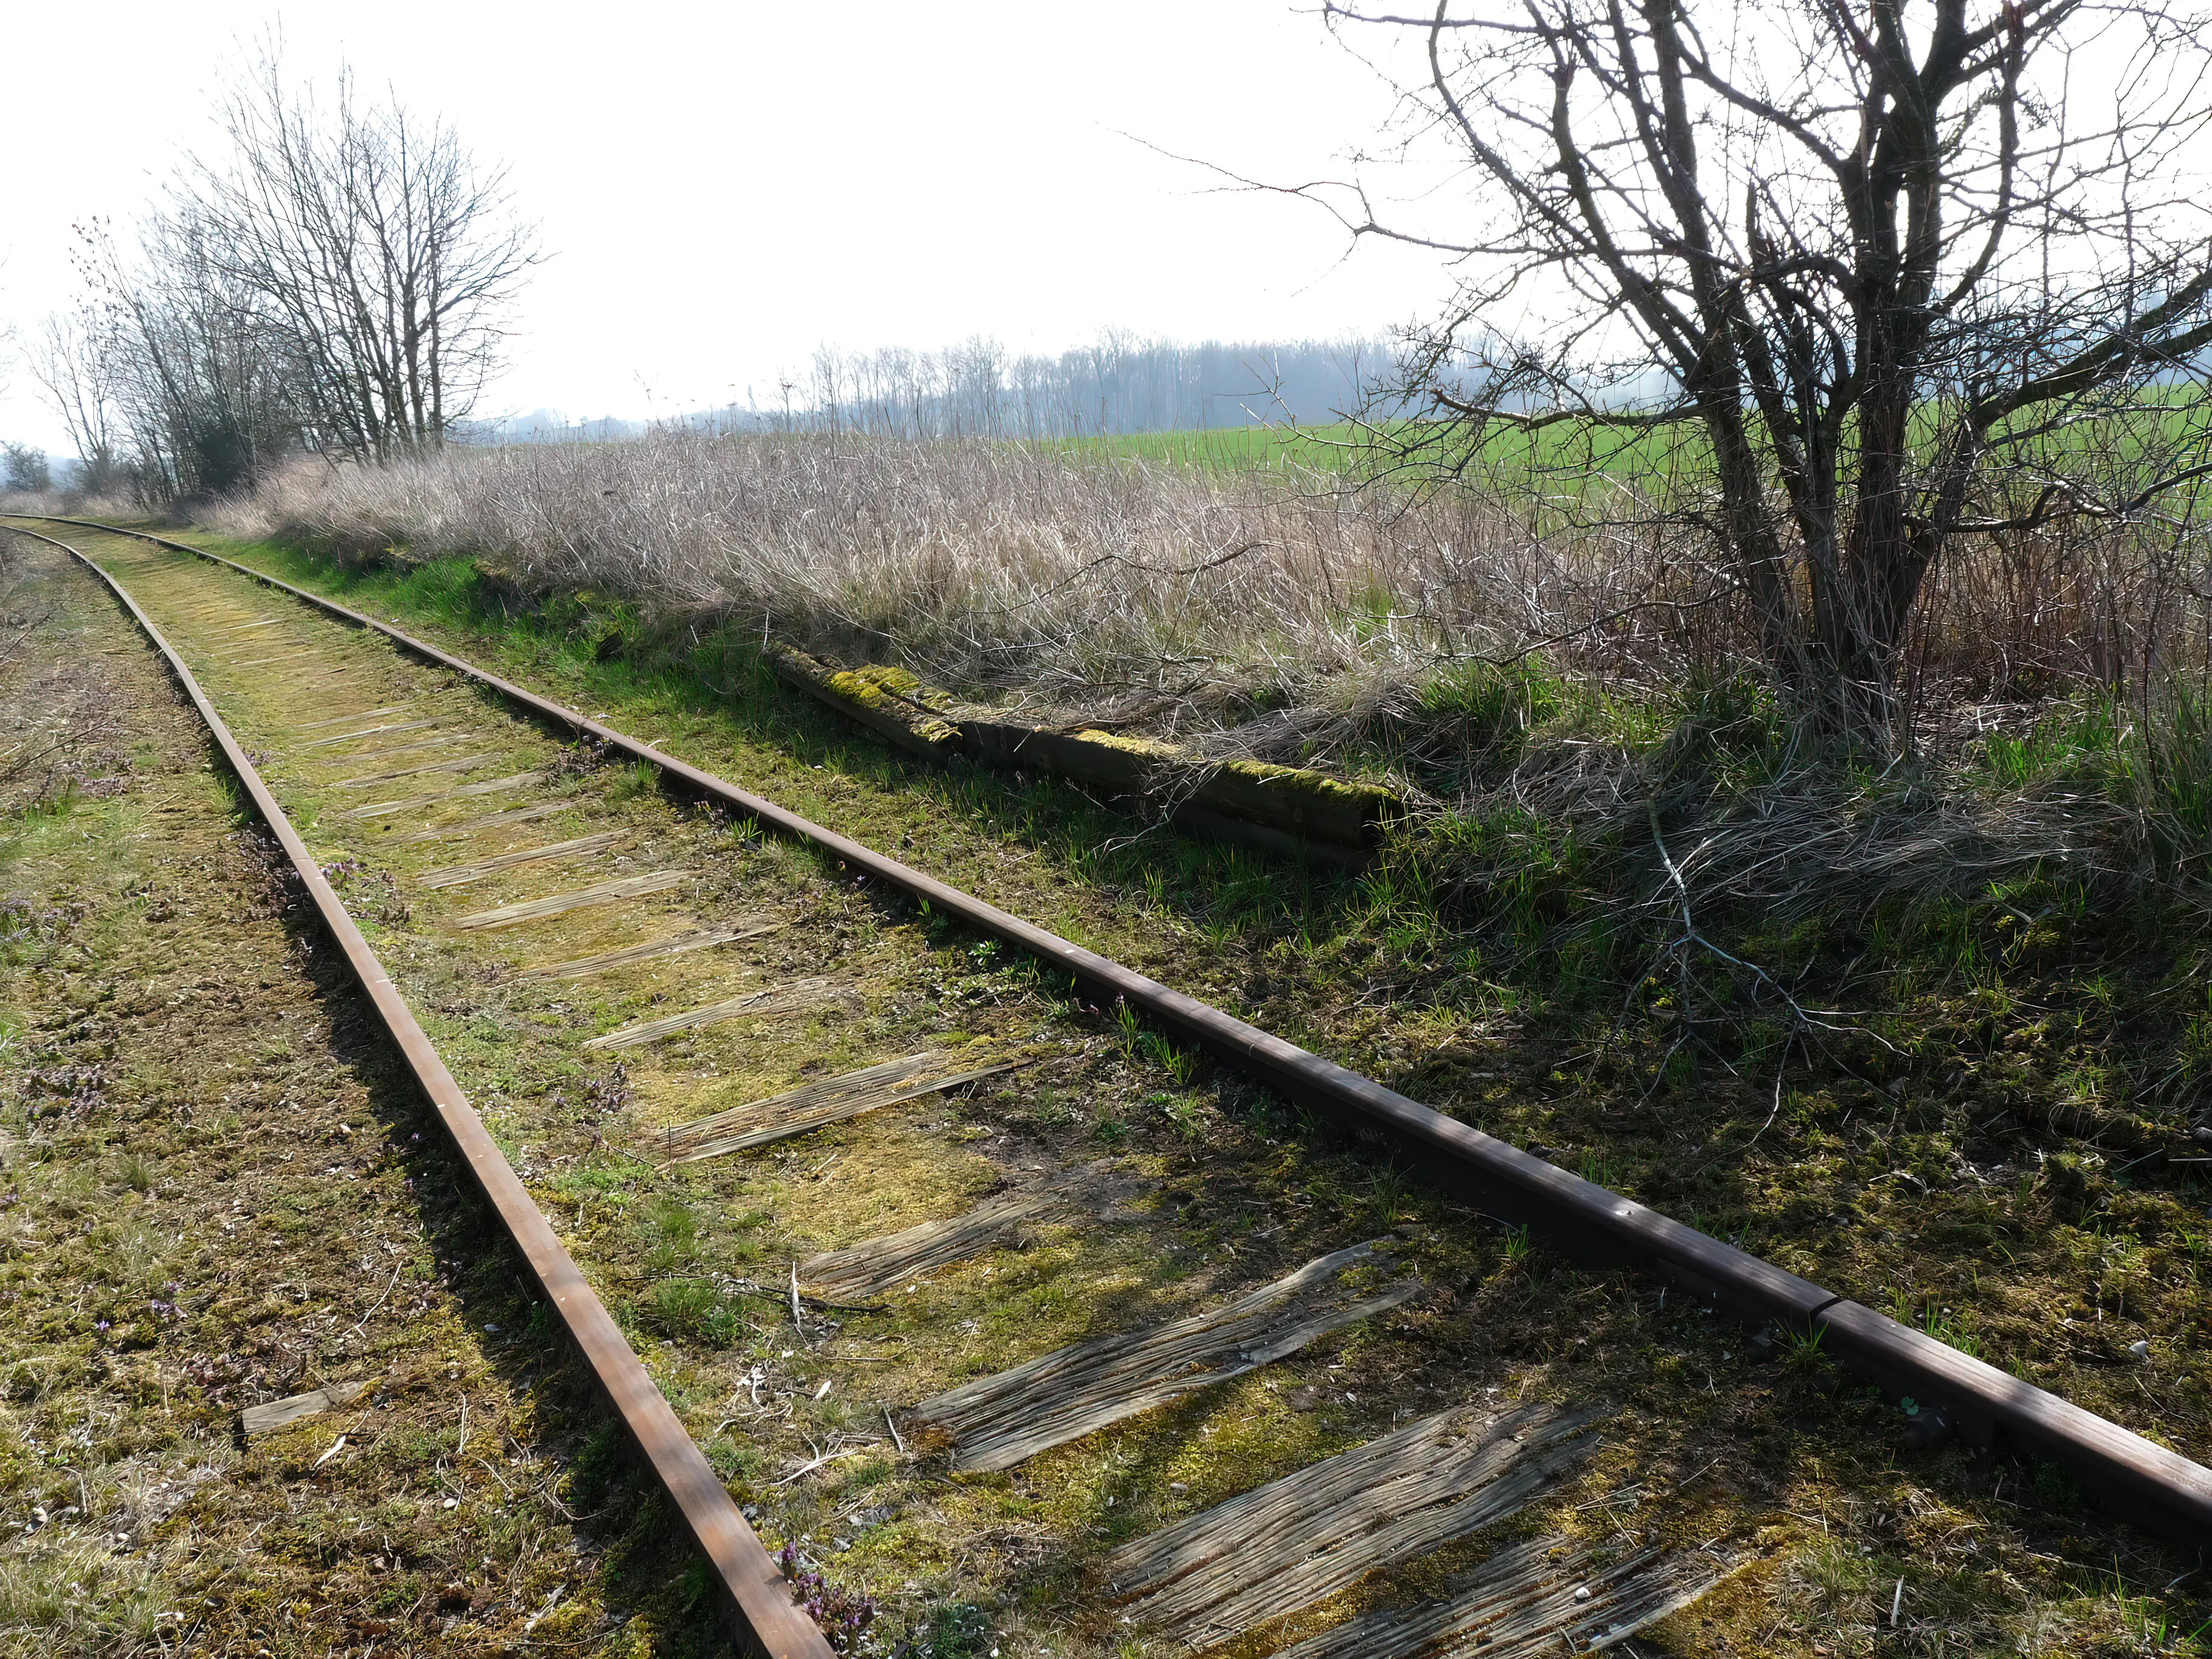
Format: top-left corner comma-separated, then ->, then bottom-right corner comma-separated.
9,520 -> 834,1659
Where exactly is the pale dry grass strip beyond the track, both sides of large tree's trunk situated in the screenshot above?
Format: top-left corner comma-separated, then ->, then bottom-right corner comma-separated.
195,429 -> 2212,760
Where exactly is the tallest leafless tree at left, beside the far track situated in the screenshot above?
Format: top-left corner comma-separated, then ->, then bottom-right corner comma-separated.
175,51 -> 537,458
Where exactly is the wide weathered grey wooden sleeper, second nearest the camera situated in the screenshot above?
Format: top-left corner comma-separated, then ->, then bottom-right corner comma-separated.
1106,1404 -> 1604,1646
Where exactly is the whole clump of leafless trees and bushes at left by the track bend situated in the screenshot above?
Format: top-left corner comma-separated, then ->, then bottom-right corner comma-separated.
31,51 -> 537,498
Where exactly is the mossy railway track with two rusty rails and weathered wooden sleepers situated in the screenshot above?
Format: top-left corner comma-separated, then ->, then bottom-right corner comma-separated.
27,513 -> 2212,1659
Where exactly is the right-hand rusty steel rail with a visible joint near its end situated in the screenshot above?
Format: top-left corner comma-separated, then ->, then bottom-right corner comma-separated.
24,515 -> 2212,1546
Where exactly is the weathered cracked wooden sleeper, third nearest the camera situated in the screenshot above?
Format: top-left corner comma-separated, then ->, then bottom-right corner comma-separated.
911,1239 -> 1420,1469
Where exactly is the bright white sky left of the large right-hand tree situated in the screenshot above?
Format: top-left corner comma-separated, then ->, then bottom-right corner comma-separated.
0,0 -> 1449,451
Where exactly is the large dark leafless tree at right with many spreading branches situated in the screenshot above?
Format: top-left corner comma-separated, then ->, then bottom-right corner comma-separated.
1301,0 -> 2212,743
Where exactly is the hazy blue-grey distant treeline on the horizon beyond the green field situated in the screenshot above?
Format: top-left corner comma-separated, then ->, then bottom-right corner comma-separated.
469,332 -> 1392,443
